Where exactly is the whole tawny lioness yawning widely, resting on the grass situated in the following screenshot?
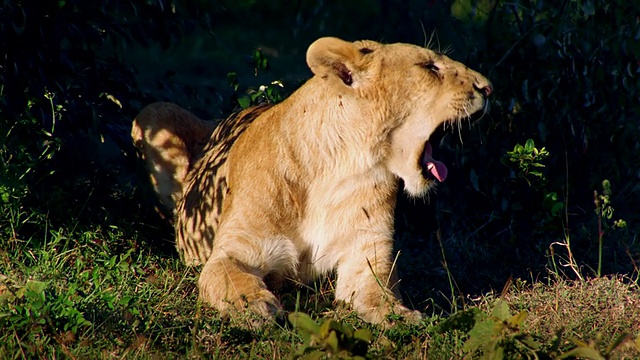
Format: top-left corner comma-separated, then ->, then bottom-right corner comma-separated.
132,37 -> 492,323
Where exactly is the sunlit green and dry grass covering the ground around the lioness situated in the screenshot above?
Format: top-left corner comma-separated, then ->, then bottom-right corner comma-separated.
0,214 -> 640,359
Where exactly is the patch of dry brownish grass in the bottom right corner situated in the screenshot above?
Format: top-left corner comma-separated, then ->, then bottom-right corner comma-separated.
504,276 -> 640,358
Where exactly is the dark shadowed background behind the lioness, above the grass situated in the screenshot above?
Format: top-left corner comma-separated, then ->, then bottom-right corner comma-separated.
0,0 -> 640,310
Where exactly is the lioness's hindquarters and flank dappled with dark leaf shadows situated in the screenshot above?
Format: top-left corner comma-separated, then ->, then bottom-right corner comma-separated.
131,102 -> 271,265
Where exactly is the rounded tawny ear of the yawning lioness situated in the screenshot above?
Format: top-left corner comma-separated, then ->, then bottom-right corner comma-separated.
307,37 -> 363,85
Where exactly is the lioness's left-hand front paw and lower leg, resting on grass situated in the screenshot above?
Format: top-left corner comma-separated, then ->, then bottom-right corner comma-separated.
198,250 -> 281,318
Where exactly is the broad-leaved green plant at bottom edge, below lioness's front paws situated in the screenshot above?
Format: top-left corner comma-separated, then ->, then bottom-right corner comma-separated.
289,312 -> 373,359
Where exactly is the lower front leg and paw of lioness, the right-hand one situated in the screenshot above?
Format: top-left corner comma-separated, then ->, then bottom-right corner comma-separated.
336,238 -> 422,323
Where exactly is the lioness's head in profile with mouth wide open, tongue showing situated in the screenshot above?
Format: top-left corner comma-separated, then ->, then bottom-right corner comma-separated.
307,38 -> 492,196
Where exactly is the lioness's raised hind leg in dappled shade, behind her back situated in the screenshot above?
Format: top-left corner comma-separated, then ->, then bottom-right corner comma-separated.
131,102 -> 215,213
